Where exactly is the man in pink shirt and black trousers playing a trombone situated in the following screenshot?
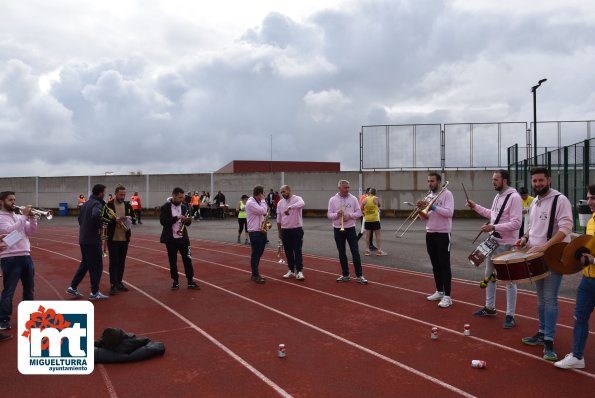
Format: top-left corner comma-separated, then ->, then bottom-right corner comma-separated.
417,172 -> 454,308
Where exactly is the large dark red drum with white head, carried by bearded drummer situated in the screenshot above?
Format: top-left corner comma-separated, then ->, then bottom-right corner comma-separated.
492,251 -> 550,283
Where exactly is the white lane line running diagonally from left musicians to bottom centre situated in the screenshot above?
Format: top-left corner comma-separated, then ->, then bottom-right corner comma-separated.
35,246 -> 292,397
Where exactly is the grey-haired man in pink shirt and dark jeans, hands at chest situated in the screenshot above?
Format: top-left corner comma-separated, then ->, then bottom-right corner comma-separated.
326,180 -> 368,285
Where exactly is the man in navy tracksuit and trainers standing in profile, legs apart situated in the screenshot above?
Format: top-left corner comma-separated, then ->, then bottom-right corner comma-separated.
66,184 -> 108,300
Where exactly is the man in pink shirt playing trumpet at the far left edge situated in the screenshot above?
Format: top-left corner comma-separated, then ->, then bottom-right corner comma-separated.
0,191 -> 37,330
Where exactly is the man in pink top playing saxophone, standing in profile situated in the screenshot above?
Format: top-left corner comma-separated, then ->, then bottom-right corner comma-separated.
246,185 -> 270,284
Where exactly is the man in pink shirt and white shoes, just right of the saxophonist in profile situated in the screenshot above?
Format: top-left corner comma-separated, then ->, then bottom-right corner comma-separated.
277,185 -> 305,281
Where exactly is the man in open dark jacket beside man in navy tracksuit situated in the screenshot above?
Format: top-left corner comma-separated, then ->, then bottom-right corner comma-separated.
103,185 -> 133,295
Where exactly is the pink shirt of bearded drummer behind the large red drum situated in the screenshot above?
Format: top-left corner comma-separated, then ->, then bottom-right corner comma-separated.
527,189 -> 573,247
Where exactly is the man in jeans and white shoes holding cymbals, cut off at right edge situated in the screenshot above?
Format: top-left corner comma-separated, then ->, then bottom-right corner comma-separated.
554,185 -> 595,369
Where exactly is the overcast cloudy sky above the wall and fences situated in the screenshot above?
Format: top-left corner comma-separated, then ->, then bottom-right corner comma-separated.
0,0 -> 595,176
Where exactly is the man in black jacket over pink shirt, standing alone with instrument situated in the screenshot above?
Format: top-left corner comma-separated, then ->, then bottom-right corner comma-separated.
159,188 -> 200,290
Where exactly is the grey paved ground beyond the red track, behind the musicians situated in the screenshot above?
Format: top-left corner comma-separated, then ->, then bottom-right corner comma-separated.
43,217 -> 581,304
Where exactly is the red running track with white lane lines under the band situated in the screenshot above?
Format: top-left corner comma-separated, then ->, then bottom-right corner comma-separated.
0,226 -> 595,397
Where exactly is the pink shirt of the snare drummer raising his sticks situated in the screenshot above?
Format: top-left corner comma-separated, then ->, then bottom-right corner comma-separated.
473,187 -> 523,245
